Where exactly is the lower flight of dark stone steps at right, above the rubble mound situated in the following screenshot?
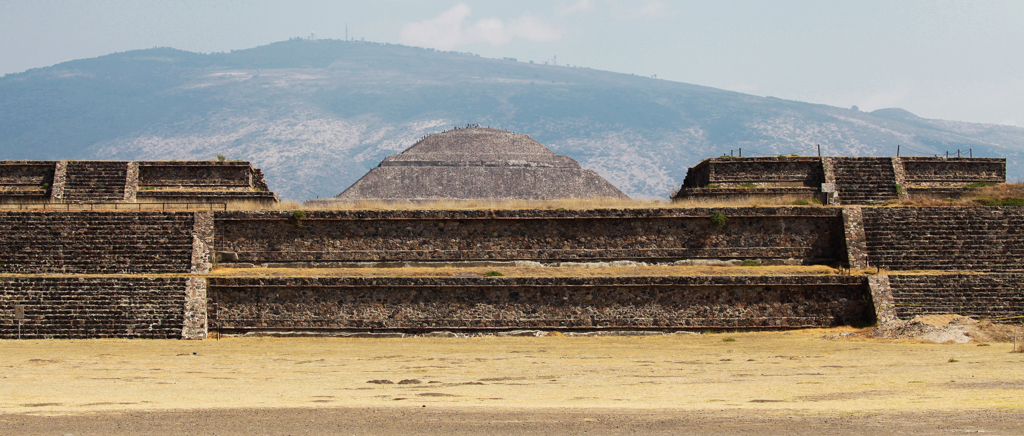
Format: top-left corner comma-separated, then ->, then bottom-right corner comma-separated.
889,273 -> 1024,321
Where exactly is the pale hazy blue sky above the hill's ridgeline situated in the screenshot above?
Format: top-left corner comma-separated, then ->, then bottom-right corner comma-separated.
6,0 -> 1024,127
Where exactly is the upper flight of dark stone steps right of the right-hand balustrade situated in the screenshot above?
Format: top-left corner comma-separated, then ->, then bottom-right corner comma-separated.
863,207 -> 1024,271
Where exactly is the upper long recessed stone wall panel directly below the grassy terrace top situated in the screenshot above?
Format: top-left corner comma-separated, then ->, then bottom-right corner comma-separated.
214,208 -> 846,264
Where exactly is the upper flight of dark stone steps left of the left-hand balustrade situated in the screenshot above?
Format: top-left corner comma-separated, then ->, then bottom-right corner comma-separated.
0,212 -> 195,274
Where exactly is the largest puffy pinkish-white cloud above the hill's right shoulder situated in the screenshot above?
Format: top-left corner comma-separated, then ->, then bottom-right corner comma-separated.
398,3 -> 561,50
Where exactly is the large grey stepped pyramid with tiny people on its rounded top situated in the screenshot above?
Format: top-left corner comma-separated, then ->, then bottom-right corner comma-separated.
335,127 -> 627,201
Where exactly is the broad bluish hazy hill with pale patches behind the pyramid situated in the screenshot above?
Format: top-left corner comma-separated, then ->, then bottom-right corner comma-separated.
0,40 -> 1024,200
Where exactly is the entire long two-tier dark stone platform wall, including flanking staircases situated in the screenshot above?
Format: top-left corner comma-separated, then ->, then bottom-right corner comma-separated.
0,202 -> 1024,338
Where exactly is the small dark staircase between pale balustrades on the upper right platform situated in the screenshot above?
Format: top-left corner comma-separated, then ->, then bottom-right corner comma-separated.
833,158 -> 899,206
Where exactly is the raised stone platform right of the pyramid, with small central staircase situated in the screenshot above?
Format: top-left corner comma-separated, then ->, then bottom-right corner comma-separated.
673,157 -> 1007,206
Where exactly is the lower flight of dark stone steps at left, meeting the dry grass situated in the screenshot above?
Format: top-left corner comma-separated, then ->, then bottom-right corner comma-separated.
0,276 -> 186,339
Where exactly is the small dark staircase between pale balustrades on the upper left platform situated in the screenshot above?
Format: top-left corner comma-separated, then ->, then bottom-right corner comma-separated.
63,161 -> 128,203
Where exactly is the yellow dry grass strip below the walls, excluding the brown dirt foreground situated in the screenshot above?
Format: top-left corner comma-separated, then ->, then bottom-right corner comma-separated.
0,329 -> 1024,415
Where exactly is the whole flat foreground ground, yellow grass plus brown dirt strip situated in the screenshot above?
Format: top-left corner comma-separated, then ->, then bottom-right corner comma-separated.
0,329 -> 1024,435
